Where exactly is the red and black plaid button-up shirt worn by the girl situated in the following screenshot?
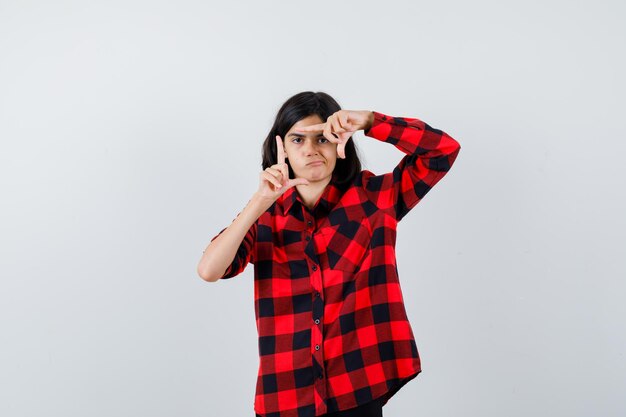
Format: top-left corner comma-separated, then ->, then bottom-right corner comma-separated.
211,112 -> 460,417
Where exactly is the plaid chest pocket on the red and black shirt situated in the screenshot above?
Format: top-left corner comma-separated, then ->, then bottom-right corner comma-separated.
320,220 -> 371,273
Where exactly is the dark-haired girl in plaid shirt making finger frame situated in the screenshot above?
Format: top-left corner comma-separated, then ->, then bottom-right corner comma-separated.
198,91 -> 460,417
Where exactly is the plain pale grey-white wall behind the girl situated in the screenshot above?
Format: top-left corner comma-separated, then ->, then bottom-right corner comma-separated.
0,0 -> 626,417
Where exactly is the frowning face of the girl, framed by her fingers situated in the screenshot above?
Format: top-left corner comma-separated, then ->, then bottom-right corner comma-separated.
283,114 -> 337,182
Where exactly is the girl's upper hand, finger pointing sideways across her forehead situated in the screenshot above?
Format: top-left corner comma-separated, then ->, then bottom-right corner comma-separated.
294,110 -> 374,159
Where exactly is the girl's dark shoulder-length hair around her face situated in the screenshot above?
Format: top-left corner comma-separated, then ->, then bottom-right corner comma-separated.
262,91 -> 361,186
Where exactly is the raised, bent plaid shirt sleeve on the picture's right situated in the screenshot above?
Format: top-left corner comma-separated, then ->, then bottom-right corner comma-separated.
363,112 -> 461,221
